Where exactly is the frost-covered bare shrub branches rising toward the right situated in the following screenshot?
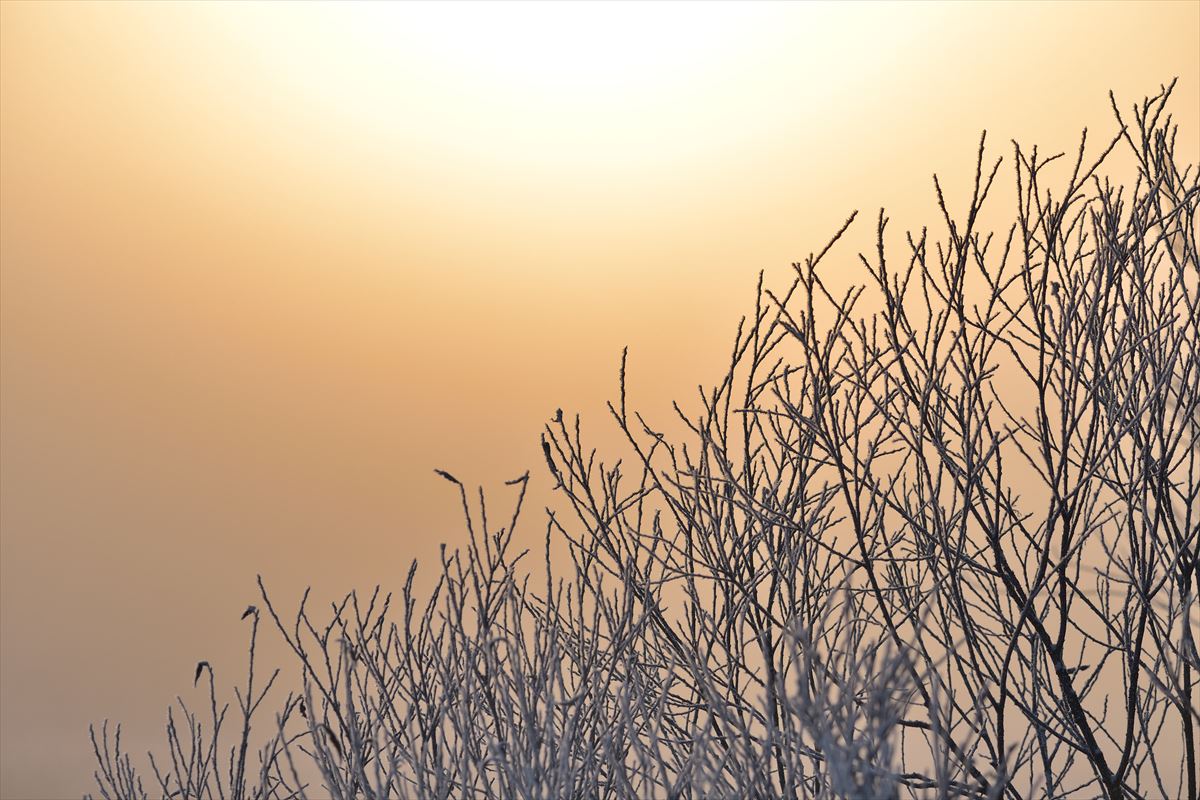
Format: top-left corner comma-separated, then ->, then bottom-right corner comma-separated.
92,84 -> 1200,800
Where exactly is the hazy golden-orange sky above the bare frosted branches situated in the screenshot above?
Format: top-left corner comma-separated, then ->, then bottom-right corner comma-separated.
0,2 -> 1200,799
